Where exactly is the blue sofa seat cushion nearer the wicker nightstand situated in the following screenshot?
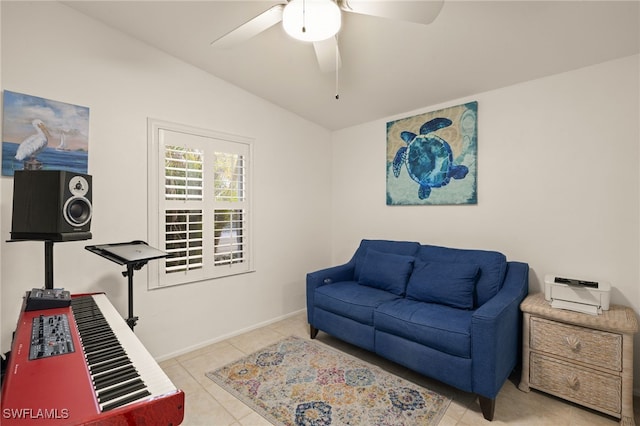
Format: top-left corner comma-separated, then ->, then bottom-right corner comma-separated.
374,299 -> 473,358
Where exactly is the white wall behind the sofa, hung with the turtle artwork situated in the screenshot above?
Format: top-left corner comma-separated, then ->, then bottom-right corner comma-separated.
332,55 -> 640,387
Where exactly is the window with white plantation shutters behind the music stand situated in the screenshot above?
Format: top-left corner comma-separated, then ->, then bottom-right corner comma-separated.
148,119 -> 252,288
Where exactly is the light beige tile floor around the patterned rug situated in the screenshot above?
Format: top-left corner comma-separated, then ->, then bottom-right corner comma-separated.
160,314 -> 640,426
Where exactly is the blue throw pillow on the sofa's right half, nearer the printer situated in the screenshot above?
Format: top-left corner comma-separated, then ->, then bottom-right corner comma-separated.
407,259 -> 480,309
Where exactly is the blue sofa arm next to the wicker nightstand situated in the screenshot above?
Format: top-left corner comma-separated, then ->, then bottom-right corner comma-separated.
471,262 -> 529,399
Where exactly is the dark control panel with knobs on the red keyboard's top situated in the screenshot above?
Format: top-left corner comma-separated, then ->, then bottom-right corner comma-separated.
29,314 -> 75,360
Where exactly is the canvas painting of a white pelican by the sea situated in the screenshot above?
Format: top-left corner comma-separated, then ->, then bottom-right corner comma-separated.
2,90 -> 89,176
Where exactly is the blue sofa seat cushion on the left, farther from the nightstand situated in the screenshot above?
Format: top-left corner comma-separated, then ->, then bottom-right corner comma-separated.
314,281 -> 399,326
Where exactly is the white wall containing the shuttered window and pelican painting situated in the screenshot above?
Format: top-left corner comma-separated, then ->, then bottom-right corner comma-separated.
0,2 -> 331,358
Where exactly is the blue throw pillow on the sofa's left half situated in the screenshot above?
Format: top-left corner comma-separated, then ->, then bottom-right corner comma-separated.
358,248 -> 415,296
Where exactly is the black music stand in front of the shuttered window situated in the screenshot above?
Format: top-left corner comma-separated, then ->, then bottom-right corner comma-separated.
85,240 -> 168,330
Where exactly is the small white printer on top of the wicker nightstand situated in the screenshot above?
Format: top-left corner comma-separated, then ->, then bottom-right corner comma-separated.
544,275 -> 611,315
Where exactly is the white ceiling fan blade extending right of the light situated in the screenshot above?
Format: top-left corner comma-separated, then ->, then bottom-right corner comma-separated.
339,0 -> 444,24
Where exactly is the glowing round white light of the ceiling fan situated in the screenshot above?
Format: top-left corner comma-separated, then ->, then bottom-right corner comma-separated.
282,0 -> 342,42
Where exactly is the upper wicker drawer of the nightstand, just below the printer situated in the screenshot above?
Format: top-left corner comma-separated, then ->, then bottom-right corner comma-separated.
530,317 -> 622,371
